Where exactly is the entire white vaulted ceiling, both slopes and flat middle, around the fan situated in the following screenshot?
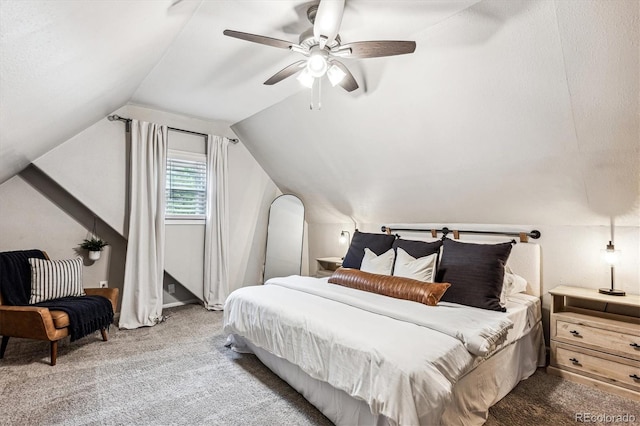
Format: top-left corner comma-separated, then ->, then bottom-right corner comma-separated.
0,0 -> 640,226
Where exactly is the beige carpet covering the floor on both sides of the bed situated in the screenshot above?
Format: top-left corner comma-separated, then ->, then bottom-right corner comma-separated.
0,305 -> 640,426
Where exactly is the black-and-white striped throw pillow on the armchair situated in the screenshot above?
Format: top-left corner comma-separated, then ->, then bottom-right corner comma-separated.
29,257 -> 85,304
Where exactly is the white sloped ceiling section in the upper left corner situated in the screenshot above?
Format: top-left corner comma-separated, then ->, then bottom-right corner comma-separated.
0,0 -> 196,183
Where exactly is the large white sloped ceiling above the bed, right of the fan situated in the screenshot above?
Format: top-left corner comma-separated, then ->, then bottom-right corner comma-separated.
233,0 -> 640,226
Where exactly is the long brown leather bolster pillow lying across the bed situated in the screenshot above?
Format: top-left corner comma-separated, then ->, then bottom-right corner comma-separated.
329,268 -> 451,306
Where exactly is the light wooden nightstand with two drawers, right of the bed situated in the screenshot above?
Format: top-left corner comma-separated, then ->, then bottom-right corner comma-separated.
547,286 -> 640,401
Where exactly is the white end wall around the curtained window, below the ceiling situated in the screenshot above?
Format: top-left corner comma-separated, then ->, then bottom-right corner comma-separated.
0,105 -> 278,308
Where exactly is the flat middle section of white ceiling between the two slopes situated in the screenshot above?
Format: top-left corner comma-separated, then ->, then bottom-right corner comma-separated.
131,0 -> 479,122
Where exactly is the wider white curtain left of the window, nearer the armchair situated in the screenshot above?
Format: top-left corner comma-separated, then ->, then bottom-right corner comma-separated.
119,120 -> 168,329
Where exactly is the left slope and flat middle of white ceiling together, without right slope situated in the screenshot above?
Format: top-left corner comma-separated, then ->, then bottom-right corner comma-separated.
0,0 -> 478,183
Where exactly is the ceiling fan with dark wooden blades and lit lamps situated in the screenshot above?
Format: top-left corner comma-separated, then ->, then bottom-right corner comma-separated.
223,0 -> 416,92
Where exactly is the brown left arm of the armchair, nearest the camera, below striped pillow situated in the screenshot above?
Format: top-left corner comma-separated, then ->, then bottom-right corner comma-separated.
0,305 -> 56,340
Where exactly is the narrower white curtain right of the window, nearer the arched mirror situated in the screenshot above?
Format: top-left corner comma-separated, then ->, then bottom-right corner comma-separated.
204,135 -> 229,310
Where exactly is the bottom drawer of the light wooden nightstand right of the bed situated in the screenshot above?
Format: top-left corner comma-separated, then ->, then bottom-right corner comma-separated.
551,342 -> 640,391
